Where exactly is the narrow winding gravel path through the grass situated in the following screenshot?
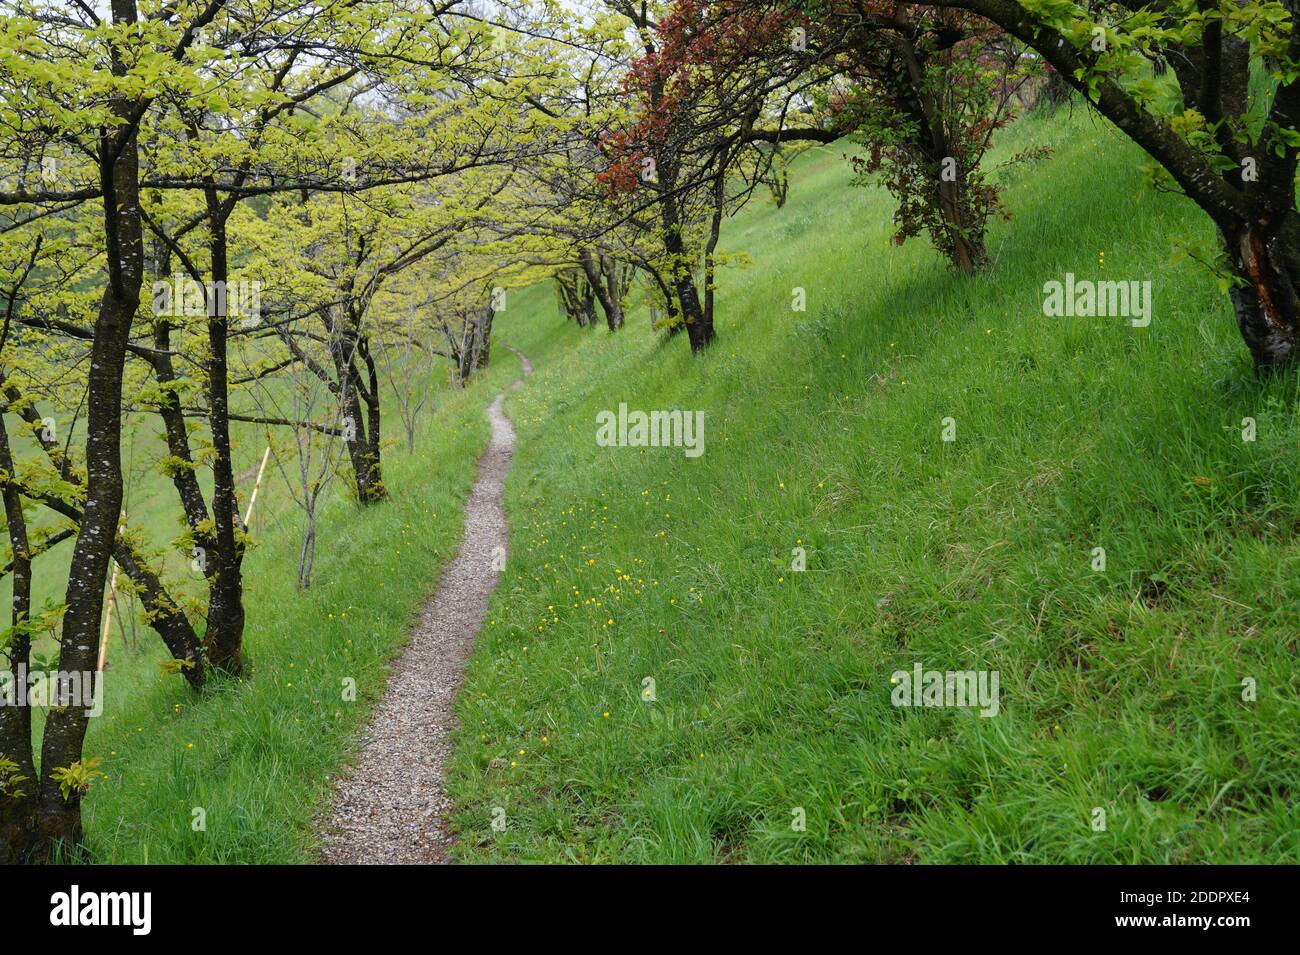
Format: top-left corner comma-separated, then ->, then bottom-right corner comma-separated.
321,342 -> 533,865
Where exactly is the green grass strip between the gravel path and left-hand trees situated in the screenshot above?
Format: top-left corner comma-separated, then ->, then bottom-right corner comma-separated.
72,348 -> 520,863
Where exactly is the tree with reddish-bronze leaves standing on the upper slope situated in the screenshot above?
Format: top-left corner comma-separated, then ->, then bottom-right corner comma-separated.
639,0 -> 1039,273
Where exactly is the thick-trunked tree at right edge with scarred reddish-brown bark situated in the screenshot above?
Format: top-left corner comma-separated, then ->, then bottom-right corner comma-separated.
821,0 -> 1300,373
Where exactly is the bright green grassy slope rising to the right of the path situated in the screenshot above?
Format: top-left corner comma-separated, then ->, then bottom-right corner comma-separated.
451,106 -> 1300,863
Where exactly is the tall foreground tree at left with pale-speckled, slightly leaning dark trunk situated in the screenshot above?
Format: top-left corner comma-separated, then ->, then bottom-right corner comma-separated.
0,0 -> 220,855
